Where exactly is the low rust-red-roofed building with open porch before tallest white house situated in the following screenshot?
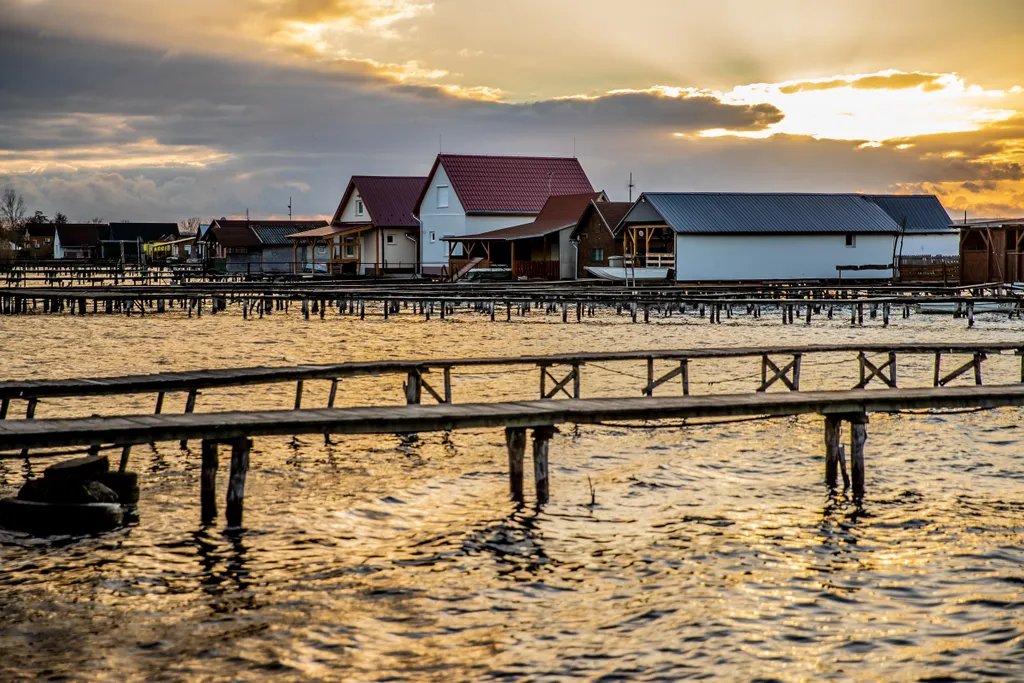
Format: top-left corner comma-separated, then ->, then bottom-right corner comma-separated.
444,193 -> 608,281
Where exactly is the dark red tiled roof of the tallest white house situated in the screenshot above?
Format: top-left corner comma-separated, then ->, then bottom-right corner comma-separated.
416,155 -> 594,214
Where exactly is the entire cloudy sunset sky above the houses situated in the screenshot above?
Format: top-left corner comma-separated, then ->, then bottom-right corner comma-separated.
0,0 -> 1024,221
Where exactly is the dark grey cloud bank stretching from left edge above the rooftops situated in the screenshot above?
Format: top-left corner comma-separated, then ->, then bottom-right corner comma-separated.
0,24 -> 781,219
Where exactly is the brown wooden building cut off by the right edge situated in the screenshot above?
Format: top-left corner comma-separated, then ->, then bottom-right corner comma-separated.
958,218 -> 1024,285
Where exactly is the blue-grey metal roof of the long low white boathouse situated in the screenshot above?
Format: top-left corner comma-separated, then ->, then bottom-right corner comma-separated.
624,193 -> 898,234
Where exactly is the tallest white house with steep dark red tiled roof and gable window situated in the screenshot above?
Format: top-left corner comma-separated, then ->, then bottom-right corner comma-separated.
415,154 -> 594,274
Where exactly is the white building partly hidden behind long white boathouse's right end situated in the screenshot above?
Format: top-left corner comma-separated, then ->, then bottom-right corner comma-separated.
864,195 -> 959,257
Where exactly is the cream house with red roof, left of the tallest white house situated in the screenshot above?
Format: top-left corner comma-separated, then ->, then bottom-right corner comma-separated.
313,175 -> 427,275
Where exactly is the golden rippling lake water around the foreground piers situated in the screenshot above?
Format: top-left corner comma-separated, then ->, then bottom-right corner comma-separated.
0,311 -> 1024,681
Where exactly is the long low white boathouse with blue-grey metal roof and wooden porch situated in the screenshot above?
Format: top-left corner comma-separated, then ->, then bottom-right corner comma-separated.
617,193 -> 898,282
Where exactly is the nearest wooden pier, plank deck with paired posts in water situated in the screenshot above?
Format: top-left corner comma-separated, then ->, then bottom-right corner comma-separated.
0,385 -> 1024,525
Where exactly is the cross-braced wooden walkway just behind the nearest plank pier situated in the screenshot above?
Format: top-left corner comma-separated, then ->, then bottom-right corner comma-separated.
0,341 -> 1024,420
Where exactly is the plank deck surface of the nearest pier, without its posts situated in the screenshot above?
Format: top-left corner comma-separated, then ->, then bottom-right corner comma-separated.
0,384 -> 1024,458
